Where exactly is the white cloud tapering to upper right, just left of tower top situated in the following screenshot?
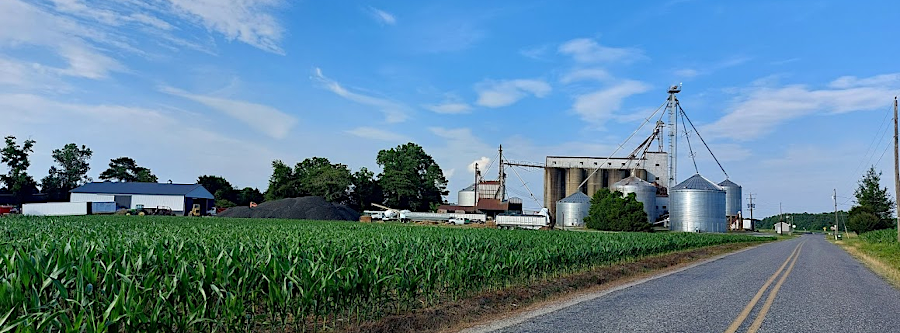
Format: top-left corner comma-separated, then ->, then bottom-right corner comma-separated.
572,80 -> 650,126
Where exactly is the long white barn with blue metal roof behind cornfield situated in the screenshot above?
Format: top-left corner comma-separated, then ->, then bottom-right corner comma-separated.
69,182 -> 215,215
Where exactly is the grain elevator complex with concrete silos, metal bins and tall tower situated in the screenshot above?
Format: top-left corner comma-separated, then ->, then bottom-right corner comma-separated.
459,86 -> 753,233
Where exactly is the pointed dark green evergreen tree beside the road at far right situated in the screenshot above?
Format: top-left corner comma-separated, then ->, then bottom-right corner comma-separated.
847,166 -> 894,234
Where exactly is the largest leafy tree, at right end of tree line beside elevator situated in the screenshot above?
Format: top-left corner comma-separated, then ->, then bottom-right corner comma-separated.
376,142 -> 449,211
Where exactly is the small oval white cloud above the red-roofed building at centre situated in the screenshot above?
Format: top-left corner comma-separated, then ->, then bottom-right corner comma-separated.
475,79 -> 552,108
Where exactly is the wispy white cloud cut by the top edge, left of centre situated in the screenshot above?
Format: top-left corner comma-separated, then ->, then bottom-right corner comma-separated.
169,0 -> 284,54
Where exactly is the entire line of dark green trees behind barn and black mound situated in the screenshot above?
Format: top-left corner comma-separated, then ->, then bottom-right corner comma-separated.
0,136 -> 448,211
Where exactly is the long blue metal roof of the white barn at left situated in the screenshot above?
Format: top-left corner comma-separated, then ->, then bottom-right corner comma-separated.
70,182 -> 215,199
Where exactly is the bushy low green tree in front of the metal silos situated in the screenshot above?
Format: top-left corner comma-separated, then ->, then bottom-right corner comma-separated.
584,188 -> 653,231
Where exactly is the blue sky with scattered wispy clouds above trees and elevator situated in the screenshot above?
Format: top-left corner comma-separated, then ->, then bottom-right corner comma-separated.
0,0 -> 900,216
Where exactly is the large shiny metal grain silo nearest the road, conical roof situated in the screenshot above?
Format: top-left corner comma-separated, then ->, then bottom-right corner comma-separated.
669,174 -> 728,232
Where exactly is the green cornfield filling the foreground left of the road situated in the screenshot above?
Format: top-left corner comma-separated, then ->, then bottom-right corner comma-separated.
0,216 -> 761,332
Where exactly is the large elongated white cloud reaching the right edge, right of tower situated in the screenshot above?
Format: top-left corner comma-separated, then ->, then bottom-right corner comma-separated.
702,74 -> 900,140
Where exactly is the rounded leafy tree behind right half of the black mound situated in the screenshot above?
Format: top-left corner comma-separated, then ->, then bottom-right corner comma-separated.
294,157 -> 353,203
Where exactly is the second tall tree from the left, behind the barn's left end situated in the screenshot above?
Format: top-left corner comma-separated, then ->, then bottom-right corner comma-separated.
41,143 -> 93,201
